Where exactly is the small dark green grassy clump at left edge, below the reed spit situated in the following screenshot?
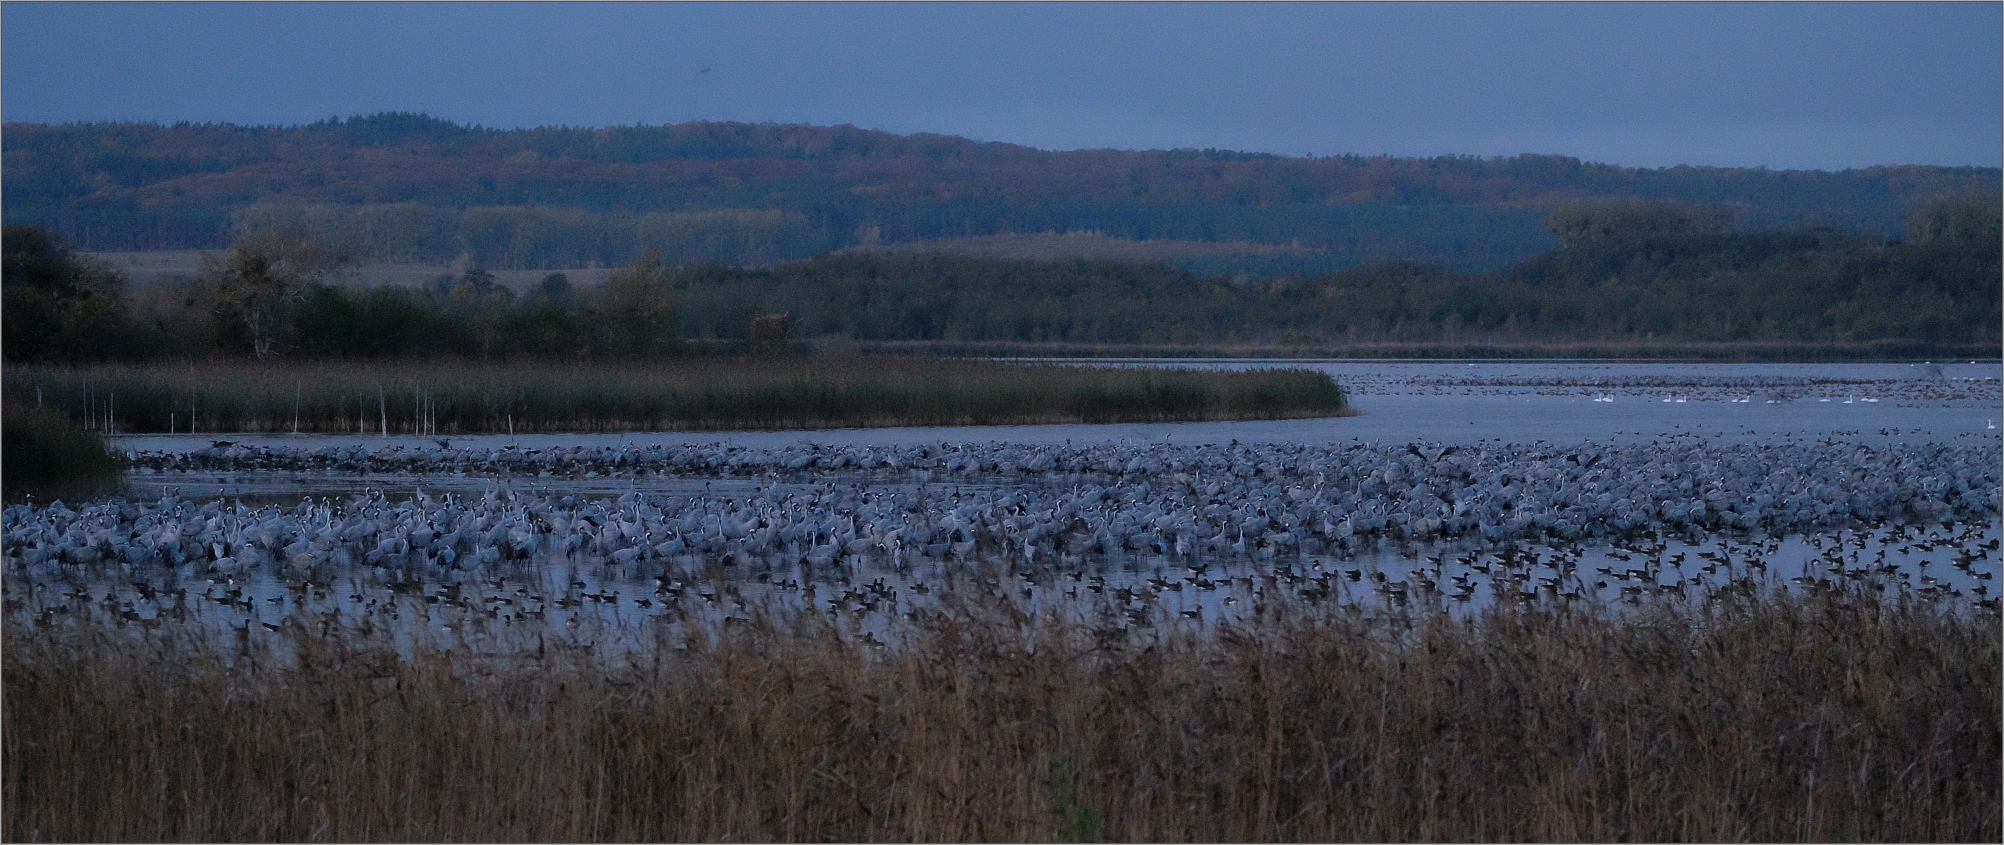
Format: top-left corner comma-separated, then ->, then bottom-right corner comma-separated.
0,402 -> 122,501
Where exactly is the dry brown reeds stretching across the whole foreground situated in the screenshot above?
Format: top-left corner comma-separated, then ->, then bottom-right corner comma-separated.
0,591 -> 2004,841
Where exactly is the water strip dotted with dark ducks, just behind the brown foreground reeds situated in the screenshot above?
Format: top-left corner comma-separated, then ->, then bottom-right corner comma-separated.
6,521 -> 2000,651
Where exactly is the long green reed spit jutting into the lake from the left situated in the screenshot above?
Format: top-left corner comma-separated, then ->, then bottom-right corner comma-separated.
4,356 -> 1349,435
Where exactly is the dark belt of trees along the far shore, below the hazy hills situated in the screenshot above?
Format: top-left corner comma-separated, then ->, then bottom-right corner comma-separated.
4,196 -> 2004,362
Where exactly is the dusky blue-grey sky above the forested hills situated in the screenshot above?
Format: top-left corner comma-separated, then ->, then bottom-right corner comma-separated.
0,2 -> 2004,170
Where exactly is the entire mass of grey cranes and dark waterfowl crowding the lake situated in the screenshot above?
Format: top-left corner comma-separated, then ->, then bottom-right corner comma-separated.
0,437 -> 2000,635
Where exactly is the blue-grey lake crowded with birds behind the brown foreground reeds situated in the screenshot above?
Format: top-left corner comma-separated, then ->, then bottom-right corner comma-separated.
8,360 -> 2004,643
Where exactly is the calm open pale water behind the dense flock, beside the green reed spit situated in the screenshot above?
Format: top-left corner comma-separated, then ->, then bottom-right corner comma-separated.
120,360 -> 2004,458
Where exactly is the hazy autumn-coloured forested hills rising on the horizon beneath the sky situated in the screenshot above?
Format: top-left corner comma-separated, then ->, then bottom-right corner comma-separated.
0,114 -> 2004,272
